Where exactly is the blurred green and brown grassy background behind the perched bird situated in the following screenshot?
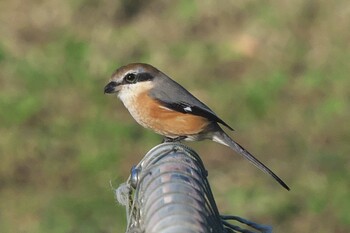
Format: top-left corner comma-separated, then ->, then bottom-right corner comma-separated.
0,0 -> 350,233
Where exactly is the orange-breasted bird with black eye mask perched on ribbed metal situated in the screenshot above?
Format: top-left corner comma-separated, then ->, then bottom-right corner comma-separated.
104,63 -> 290,190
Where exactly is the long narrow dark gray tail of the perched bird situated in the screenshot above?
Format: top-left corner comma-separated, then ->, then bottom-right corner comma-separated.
212,131 -> 290,190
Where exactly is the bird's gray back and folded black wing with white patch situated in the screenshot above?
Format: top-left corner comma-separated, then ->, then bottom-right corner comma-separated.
150,73 -> 233,130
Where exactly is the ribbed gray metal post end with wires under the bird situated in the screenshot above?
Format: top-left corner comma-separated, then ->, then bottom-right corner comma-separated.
116,143 -> 272,233
